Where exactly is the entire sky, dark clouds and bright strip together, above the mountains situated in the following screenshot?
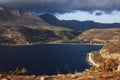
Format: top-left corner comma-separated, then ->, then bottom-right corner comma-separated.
0,0 -> 120,23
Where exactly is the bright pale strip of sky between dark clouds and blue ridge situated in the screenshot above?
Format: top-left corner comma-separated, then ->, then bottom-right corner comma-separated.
56,10 -> 120,23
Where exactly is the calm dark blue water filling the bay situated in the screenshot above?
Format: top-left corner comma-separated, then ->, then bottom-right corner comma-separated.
0,44 -> 102,75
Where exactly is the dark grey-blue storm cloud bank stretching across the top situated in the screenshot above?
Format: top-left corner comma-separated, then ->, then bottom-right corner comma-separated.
0,0 -> 120,13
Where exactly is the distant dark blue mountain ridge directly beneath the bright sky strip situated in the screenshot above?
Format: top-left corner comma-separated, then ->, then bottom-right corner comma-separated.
39,14 -> 120,30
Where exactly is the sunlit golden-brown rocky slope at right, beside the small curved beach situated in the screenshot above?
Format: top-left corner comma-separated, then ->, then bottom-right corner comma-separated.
89,36 -> 120,68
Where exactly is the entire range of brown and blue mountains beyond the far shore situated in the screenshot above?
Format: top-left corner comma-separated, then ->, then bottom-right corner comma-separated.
0,6 -> 120,45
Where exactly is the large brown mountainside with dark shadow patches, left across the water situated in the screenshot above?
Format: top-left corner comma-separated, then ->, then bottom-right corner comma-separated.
0,6 -> 78,45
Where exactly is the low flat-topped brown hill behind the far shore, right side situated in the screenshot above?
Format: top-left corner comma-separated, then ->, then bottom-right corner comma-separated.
74,28 -> 120,44
